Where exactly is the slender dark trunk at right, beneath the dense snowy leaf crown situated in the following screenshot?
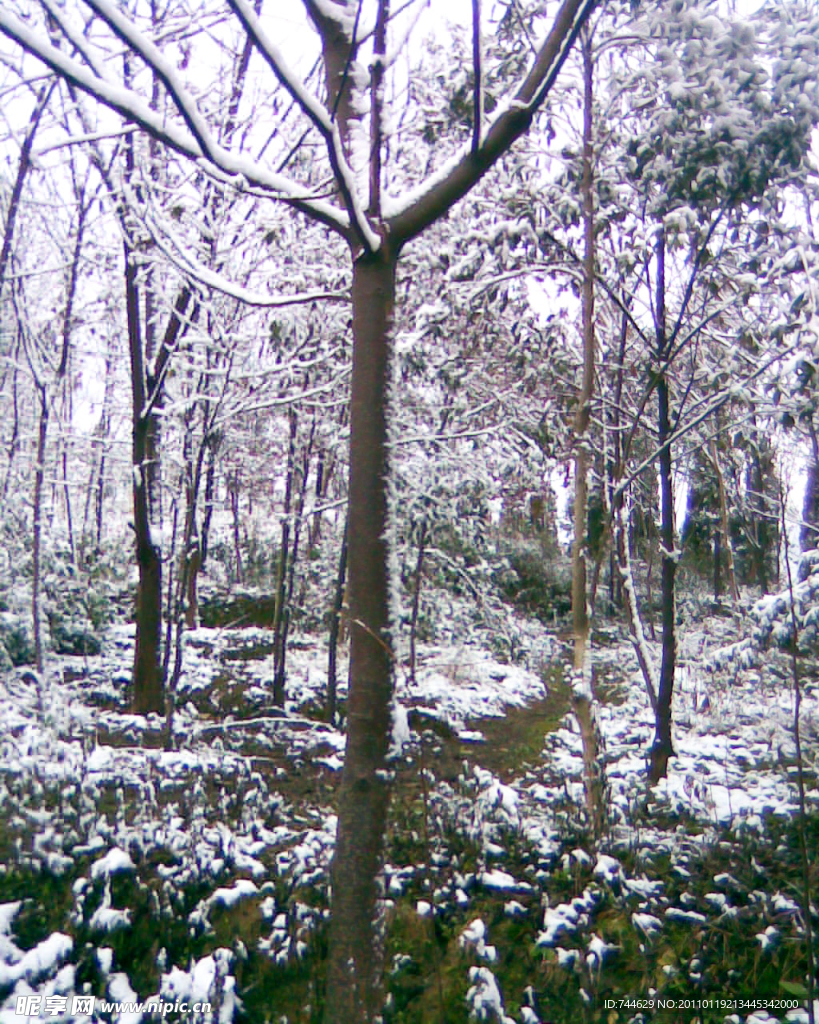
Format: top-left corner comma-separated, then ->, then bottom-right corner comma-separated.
649,230 -> 678,782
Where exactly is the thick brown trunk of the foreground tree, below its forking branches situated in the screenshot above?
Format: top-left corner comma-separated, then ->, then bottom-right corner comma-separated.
325,246 -> 395,1024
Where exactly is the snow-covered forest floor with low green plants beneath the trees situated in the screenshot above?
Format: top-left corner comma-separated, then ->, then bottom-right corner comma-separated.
0,602 -> 819,1024
